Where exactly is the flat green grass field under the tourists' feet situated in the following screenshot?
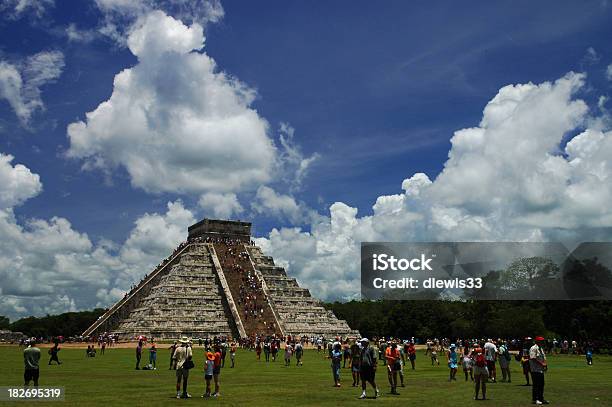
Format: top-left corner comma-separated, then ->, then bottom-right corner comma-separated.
0,346 -> 612,407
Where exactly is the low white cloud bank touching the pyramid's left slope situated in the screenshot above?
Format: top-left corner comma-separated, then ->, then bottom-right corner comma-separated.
0,150 -> 195,319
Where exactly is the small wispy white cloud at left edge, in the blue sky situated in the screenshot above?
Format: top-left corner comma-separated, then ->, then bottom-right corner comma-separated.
0,51 -> 64,126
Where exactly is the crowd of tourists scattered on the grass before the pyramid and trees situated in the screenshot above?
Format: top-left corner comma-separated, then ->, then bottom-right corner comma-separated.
23,335 -> 604,405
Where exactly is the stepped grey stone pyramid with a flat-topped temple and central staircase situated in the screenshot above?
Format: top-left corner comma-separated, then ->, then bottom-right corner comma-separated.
83,219 -> 358,339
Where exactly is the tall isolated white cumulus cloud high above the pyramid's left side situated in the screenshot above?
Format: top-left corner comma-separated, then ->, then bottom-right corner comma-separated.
68,11 -> 276,193
